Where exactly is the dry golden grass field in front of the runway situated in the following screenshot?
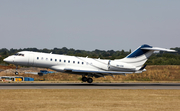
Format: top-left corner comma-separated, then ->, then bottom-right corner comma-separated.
0,89 -> 180,111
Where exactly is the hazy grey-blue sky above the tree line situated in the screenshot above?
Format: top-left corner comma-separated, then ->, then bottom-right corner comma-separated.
0,0 -> 180,51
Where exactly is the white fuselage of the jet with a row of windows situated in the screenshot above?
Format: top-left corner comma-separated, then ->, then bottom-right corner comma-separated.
4,51 -> 135,72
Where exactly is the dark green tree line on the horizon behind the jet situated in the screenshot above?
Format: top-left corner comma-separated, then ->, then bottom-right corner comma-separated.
0,47 -> 180,65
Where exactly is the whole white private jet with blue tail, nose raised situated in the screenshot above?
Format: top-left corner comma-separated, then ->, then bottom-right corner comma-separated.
4,44 -> 176,83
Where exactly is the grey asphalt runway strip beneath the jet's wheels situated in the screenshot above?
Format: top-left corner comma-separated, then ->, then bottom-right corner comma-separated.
0,83 -> 180,89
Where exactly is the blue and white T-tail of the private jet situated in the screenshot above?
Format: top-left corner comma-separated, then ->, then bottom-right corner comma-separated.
117,44 -> 176,71
